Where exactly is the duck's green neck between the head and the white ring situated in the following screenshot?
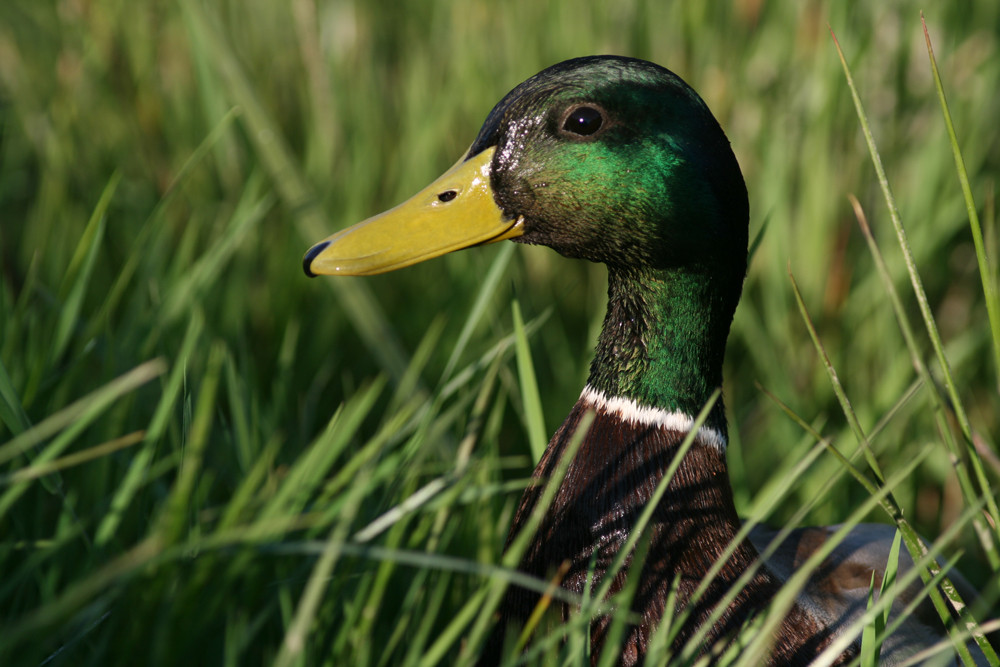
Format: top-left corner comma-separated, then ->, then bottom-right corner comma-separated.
588,266 -> 742,439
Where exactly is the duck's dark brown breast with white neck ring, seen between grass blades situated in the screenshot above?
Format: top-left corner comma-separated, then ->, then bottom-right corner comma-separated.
496,390 -> 829,664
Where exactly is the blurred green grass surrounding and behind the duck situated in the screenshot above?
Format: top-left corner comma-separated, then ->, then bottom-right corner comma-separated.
0,0 -> 1000,665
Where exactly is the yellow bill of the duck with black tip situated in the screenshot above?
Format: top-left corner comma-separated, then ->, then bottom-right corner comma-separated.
302,148 -> 524,276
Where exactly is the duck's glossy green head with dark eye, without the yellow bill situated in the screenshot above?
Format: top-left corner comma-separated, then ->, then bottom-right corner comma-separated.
469,56 -> 748,280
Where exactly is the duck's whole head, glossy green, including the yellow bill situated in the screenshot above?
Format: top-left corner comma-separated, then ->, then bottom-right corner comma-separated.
303,56 -> 747,284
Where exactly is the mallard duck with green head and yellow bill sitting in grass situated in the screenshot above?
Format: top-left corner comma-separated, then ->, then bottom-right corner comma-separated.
304,56 -> 984,664
